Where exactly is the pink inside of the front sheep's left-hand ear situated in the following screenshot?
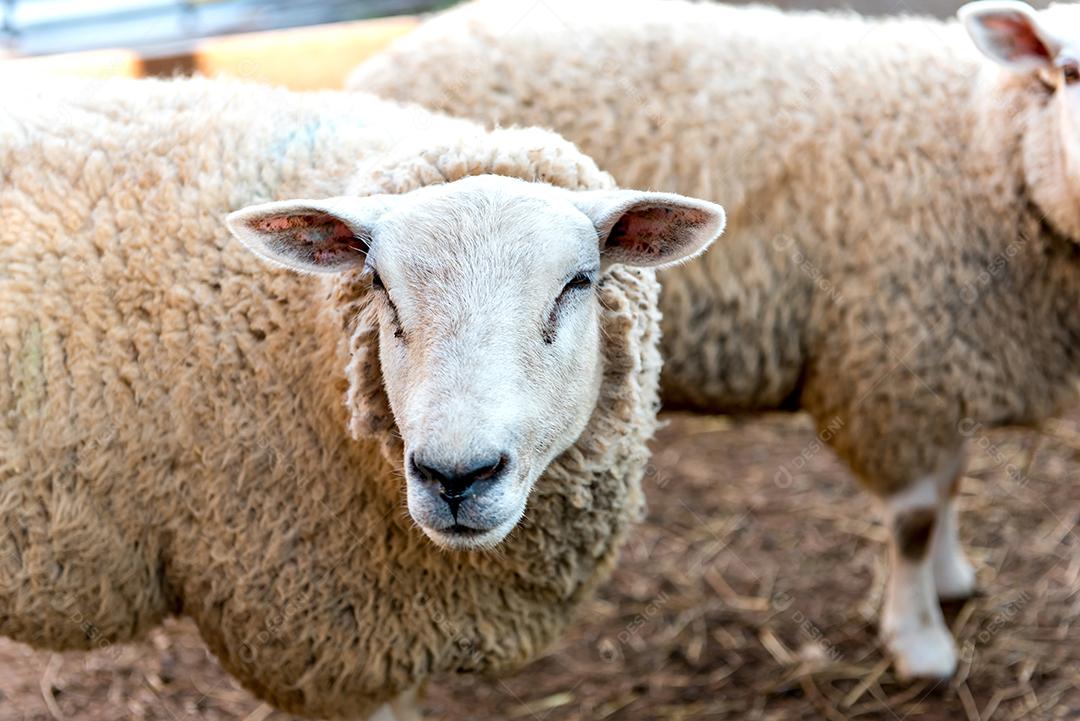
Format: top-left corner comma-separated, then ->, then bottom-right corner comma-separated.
254,213 -> 367,268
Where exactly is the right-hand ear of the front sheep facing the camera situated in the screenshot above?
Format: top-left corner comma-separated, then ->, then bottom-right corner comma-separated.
573,190 -> 725,268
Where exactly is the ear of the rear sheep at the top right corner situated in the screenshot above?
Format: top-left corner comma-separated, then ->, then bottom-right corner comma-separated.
957,0 -> 1061,72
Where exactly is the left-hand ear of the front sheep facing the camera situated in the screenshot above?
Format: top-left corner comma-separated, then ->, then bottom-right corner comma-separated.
226,195 -> 388,273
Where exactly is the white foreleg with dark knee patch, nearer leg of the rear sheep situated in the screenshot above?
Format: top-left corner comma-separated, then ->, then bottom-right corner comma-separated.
881,464 -> 957,679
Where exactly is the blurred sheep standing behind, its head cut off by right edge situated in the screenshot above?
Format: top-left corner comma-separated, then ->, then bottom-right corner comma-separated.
349,0 -> 1080,678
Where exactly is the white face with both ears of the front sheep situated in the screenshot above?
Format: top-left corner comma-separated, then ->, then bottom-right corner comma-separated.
229,176 -> 724,548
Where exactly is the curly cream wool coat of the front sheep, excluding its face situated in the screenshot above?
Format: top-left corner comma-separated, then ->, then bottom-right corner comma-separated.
0,80 -> 660,717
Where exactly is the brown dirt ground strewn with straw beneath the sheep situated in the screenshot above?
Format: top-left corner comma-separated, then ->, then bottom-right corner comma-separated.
0,414 -> 1080,721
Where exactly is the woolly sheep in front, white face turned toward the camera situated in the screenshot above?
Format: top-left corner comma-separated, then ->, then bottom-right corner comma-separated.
0,80 -> 723,719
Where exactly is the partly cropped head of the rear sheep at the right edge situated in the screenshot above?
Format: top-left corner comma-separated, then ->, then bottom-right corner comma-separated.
960,0 -> 1080,241
